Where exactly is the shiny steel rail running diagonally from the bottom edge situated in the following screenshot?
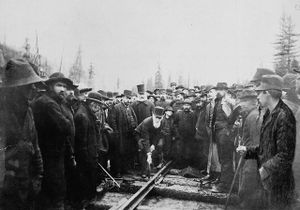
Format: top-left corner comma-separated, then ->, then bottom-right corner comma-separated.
110,161 -> 173,210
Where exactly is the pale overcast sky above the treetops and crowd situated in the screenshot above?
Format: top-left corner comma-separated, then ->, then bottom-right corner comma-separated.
0,0 -> 300,90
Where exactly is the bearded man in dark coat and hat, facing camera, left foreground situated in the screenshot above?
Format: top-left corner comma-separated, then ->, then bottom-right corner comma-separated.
32,72 -> 74,210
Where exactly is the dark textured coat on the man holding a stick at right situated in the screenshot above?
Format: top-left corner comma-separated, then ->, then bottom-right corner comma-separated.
245,100 -> 296,209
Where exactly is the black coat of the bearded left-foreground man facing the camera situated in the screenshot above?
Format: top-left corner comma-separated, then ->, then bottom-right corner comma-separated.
32,92 -> 74,202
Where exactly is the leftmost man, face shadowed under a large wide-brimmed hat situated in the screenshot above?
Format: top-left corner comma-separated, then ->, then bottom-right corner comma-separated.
0,59 -> 43,210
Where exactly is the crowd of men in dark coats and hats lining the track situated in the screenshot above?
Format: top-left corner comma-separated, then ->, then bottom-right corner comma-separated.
0,59 -> 300,210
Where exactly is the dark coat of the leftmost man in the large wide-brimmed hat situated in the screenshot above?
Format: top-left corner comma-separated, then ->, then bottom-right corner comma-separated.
0,104 -> 43,209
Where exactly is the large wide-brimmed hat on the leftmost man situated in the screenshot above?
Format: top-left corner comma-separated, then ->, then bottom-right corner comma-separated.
0,59 -> 44,87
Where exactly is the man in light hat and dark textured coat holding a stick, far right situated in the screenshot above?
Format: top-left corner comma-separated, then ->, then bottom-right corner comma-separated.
237,75 -> 296,210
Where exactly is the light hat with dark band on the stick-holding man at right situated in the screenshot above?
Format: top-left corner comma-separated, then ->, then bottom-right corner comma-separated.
255,74 -> 284,91
